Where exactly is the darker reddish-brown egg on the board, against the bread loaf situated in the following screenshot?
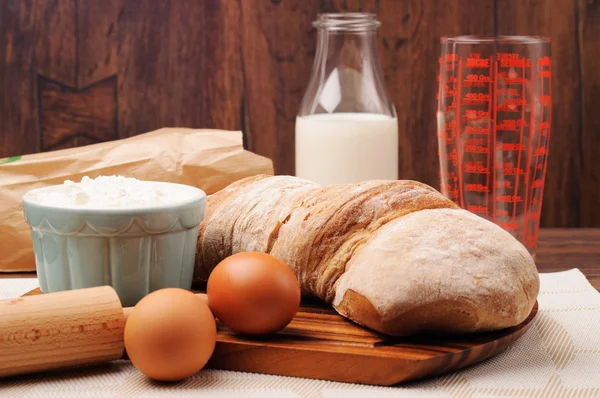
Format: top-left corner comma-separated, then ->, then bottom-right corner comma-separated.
206,252 -> 300,335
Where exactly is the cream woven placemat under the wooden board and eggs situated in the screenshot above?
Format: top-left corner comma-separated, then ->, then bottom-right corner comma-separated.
0,269 -> 600,398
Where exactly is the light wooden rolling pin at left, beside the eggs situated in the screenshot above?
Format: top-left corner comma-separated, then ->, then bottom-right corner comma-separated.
0,286 -> 131,377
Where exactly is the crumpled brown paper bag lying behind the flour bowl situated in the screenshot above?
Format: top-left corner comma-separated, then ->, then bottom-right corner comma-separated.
0,128 -> 273,272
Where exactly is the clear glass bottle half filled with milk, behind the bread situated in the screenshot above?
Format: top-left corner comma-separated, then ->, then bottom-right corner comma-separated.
296,13 -> 398,185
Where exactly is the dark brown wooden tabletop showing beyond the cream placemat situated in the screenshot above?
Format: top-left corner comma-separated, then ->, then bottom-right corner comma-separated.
0,228 -> 600,290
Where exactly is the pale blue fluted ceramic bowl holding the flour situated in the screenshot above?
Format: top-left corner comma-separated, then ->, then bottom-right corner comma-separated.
23,182 -> 206,306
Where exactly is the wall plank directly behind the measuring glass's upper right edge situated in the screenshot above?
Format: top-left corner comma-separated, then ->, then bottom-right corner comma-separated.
497,0 -> 585,227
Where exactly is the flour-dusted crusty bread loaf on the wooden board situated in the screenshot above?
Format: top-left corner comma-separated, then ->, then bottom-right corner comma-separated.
194,176 -> 539,336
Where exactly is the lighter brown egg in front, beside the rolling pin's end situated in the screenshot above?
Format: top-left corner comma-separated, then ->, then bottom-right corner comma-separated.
125,289 -> 217,381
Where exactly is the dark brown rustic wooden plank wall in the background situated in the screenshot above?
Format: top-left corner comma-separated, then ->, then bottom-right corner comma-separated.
0,0 -> 600,227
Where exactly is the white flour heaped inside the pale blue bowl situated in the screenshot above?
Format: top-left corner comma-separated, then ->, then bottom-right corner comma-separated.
31,176 -> 197,209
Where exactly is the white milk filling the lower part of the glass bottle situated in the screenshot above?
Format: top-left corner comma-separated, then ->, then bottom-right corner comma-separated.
296,113 -> 398,185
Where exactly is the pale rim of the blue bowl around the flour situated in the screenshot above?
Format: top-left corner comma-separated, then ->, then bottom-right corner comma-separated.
21,181 -> 207,216
